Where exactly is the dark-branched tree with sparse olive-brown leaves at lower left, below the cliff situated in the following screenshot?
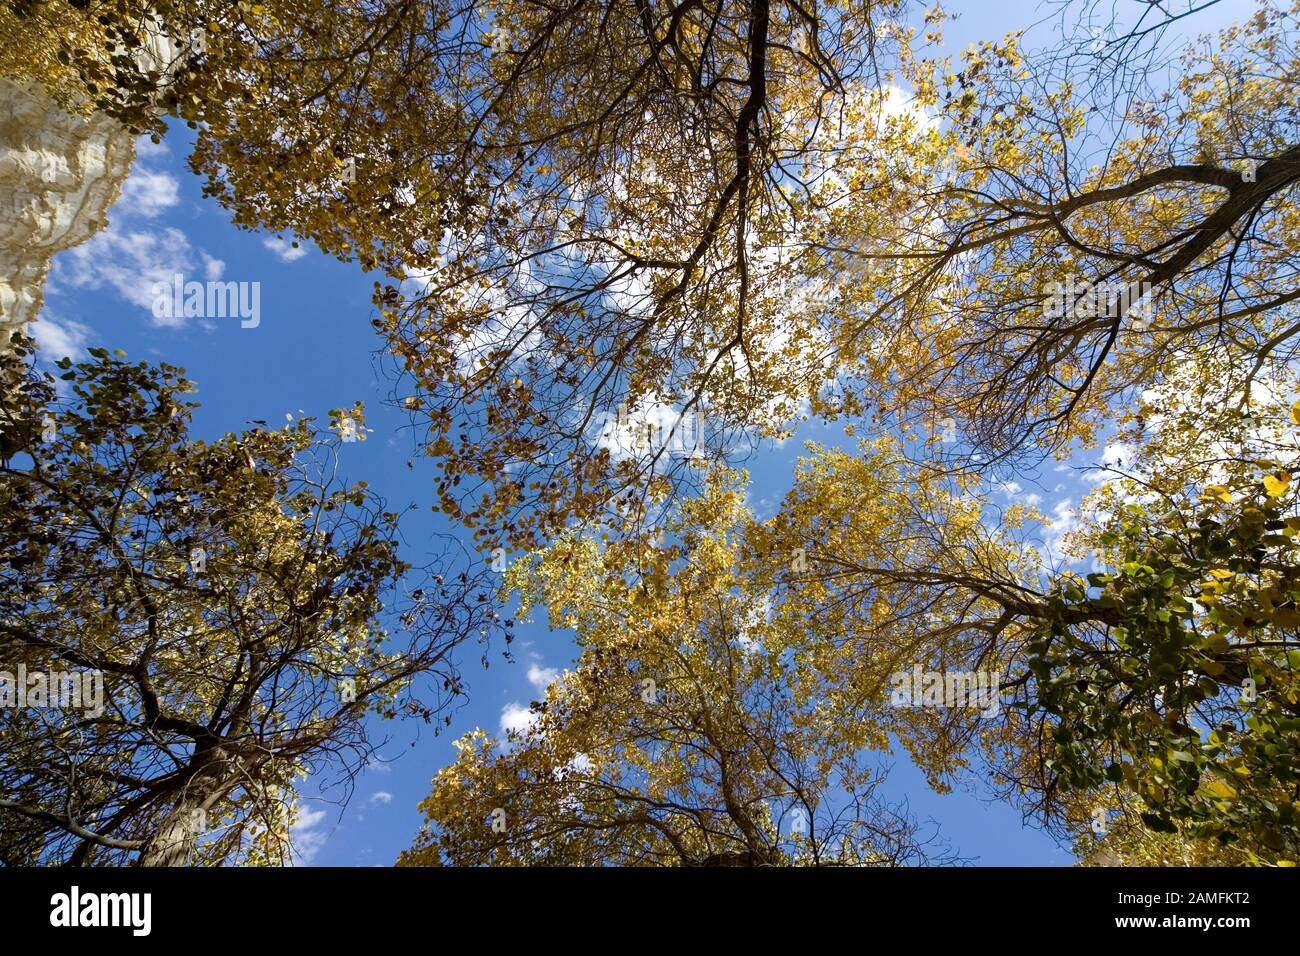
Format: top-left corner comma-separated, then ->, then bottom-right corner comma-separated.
0,342 -> 508,865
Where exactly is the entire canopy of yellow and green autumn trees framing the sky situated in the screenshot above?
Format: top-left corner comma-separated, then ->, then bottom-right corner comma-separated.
0,0 -> 1300,865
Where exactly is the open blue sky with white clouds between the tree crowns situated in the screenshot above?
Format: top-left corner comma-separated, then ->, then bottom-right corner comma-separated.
33,3 -> 1247,865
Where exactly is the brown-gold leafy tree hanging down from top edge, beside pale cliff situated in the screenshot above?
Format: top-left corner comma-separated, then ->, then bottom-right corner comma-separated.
2,0 -> 904,546
